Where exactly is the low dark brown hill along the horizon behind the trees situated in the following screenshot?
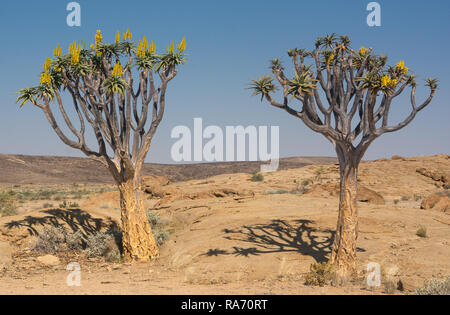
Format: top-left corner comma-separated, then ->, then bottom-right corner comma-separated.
0,154 -> 337,184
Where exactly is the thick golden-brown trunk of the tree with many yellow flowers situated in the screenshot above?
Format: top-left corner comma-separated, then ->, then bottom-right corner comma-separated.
119,179 -> 159,261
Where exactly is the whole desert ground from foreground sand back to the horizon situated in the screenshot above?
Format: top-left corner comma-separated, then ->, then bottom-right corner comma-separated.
0,154 -> 450,294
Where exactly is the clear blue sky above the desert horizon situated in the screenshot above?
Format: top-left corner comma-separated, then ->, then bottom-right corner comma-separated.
0,0 -> 450,163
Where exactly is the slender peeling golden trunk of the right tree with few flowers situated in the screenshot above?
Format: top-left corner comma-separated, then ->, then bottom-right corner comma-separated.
329,154 -> 358,285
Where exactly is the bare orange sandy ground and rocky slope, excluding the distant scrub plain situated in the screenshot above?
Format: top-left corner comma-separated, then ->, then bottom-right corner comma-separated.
0,155 -> 450,294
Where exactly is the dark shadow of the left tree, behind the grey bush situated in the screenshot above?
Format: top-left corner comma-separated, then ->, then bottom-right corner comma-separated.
4,209 -> 117,236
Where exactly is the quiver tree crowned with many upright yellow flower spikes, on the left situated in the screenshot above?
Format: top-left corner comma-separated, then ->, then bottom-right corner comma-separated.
17,30 -> 185,261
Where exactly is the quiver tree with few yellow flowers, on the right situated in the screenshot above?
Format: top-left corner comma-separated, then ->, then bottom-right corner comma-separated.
249,34 -> 437,284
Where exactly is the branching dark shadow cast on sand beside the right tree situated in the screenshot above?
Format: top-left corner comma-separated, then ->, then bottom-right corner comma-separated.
205,220 -> 335,262
